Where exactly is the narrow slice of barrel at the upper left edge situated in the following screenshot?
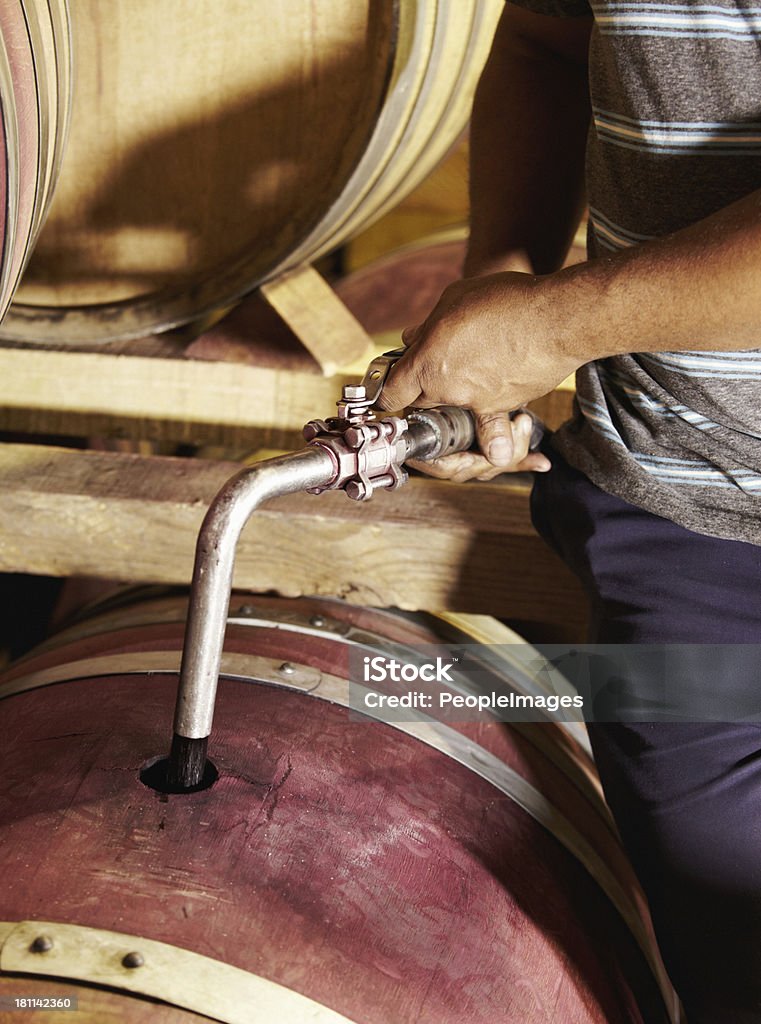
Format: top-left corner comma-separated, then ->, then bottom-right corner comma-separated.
0,0 -> 71,318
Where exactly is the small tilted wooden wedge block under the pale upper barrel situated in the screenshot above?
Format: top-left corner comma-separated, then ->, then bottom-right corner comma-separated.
259,264 -> 373,377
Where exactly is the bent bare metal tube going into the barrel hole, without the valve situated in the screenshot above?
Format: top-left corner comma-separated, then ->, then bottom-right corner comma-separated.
168,445 -> 336,790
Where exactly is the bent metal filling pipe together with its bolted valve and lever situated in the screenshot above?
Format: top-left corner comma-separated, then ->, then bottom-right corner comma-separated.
167,349 -> 540,793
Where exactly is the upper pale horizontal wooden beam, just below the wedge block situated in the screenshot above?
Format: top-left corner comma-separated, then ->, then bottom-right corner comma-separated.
0,347 -> 350,444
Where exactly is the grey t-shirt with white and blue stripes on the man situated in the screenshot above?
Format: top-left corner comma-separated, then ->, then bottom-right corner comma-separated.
514,0 -> 761,544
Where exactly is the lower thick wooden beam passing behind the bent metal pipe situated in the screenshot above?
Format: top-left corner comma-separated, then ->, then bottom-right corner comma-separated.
0,440 -> 584,625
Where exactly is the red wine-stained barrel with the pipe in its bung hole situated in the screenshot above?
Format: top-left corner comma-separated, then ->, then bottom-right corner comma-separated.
0,596 -> 670,1024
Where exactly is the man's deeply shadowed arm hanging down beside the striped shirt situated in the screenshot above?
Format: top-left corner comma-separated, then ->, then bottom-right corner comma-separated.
465,5 -> 589,275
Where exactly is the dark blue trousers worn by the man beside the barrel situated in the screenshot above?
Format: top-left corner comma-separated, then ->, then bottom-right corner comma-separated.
532,450 -> 761,1024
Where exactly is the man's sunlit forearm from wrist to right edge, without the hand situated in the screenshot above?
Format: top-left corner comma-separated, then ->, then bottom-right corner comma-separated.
548,191 -> 761,364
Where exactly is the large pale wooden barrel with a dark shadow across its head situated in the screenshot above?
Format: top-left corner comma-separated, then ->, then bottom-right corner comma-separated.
2,0 -> 502,343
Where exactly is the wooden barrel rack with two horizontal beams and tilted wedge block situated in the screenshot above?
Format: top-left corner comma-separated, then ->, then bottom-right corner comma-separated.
0,270 -> 582,627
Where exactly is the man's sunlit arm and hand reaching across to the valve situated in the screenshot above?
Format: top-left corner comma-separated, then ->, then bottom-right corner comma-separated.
383,180 -> 761,414
